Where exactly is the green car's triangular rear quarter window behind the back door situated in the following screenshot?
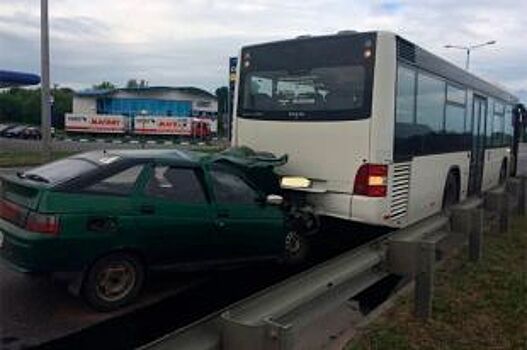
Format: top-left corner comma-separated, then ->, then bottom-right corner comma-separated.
84,164 -> 144,195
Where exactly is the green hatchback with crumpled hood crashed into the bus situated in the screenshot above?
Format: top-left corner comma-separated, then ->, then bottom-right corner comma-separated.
0,150 -> 307,310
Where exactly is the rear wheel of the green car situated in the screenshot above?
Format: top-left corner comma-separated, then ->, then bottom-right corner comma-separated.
82,253 -> 145,311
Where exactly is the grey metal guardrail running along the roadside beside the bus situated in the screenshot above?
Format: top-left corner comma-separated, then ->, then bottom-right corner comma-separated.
142,178 -> 527,350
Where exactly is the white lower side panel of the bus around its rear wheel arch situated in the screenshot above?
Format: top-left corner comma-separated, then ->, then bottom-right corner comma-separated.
408,152 -> 470,225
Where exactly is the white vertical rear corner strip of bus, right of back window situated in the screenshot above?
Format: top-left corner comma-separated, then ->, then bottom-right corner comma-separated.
370,32 -> 397,164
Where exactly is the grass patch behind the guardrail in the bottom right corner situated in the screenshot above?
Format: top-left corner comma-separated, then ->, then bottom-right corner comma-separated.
346,219 -> 527,350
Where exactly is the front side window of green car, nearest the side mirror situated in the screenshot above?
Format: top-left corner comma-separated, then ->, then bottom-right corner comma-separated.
210,170 -> 259,204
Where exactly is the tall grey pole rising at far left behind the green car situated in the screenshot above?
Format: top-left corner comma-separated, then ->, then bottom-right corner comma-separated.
40,0 -> 51,160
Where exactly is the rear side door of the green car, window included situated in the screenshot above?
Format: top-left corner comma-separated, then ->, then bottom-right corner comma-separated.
136,164 -> 219,265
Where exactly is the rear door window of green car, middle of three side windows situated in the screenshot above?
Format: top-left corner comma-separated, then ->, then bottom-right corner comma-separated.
145,166 -> 206,203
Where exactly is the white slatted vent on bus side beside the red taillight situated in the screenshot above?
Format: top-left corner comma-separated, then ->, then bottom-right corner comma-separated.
390,163 -> 411,220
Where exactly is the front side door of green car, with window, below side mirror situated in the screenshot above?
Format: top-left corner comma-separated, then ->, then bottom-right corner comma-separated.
205,165 -> 285,259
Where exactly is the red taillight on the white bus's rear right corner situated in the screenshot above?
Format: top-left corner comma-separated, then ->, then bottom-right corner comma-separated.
353,164 -> 388,197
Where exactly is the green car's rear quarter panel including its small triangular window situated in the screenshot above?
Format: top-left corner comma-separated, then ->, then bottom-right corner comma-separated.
39,164 -> 148,270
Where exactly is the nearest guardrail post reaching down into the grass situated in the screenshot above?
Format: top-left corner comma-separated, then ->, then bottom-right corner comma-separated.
414,241 -> 435,320
